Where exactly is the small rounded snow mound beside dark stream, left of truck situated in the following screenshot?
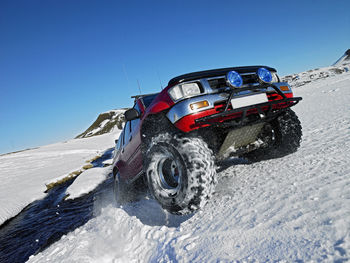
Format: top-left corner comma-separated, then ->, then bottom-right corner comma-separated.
66,166 -> 112,199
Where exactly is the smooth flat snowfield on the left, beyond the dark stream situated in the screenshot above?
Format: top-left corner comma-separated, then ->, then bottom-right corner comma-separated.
0,131 -> 120,224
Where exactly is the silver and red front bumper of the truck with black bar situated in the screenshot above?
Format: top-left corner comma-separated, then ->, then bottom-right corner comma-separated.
167,83 -> 302,132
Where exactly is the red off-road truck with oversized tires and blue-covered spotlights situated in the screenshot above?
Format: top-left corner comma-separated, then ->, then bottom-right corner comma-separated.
113,66 -> 302,214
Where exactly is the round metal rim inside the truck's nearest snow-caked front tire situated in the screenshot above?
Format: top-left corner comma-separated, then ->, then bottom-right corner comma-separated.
157,156 -> 182,195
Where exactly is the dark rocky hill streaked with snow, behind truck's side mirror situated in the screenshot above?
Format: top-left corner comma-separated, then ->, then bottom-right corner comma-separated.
76,109 -> 126,139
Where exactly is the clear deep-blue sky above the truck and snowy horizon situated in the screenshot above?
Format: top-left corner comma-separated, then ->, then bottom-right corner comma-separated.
0,0 -> 350,153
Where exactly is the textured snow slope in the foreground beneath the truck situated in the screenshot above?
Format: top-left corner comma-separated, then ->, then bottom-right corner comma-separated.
25,73 -> 350,262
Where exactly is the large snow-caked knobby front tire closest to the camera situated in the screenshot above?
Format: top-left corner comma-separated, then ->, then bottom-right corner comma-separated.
144,134 -> 216,214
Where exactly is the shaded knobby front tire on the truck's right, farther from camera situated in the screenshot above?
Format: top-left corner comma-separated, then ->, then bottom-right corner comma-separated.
243,109 -> 302,161
